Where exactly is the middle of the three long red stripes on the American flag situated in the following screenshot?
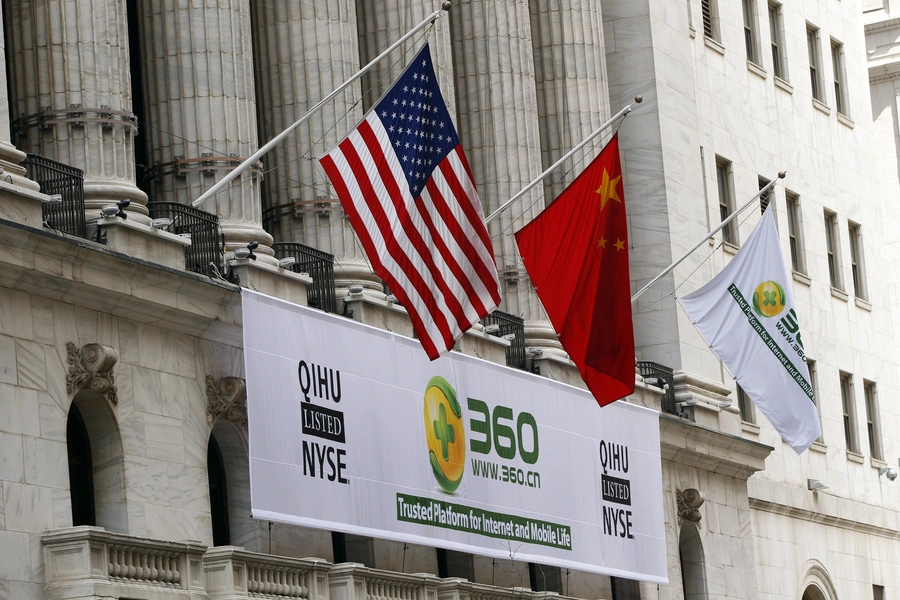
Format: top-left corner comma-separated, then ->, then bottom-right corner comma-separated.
338,134 -> 456,348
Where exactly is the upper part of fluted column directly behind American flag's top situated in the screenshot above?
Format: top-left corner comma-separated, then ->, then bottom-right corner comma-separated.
356,0 -> 456,119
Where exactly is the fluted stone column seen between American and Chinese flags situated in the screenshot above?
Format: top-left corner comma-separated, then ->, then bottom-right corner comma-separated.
450,0 -> 559,348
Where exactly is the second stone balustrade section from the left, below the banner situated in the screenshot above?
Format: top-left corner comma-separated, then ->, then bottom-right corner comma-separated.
203,546 -> 331,600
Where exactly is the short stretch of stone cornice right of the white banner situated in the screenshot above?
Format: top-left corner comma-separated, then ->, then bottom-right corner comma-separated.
659,413 -> 774,480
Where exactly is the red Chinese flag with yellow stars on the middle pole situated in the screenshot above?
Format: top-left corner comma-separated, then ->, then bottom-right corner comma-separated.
516,134 -> 634,406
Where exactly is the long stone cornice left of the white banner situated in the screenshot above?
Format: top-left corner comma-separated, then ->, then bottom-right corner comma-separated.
0,219 -> 241,345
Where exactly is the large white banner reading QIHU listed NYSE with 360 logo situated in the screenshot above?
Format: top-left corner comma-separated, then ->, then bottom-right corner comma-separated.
241,289 -> 668,583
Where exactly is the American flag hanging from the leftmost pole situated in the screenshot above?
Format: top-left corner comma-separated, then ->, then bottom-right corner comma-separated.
321,44 -> 500,360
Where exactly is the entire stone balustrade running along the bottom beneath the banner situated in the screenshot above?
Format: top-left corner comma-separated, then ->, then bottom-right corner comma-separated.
41,527 -> 600,600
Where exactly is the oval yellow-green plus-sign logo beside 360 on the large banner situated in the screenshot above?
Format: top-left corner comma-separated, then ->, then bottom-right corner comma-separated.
425,376 -> 466,493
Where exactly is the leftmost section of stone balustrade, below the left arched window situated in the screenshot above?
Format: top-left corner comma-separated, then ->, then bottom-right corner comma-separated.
41,527 -> 206,600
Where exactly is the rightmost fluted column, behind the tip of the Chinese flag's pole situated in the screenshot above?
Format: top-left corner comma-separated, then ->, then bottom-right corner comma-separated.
529,0 -> 609,203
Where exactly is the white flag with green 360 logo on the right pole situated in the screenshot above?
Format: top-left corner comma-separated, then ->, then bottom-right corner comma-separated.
680,206 -> 822,454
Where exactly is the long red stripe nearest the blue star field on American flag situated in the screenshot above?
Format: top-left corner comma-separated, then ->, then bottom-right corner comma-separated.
358,121 -> 471,336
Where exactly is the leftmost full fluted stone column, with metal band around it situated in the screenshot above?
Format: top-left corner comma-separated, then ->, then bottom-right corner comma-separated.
6,0 -> 149,214
